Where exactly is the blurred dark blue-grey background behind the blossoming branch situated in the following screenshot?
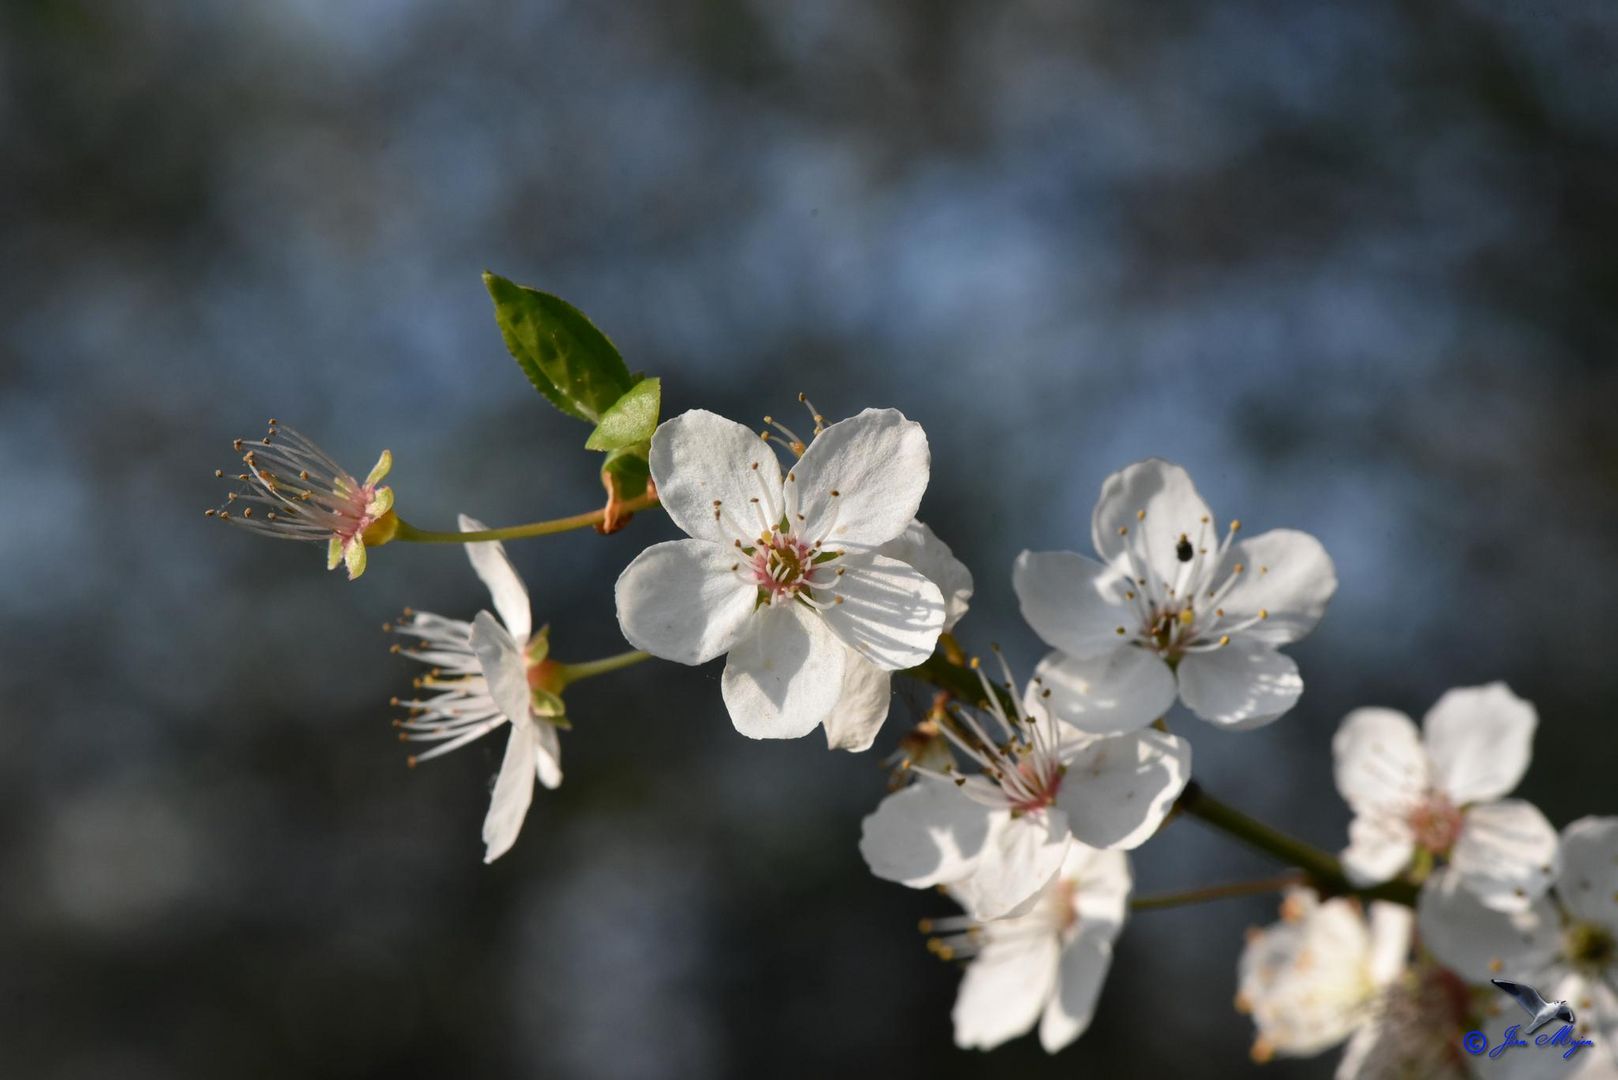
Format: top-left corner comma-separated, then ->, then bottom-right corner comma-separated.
0,0 -> 1618,1078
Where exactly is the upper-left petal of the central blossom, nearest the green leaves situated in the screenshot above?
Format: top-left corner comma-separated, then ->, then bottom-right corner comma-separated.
650,408 -> 783,547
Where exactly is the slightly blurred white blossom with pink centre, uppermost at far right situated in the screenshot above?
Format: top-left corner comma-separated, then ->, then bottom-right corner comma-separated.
1332,683 -> 1558,912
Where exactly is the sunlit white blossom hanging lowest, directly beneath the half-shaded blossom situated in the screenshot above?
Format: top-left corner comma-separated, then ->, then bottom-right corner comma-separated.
922,844 -> 1131,1054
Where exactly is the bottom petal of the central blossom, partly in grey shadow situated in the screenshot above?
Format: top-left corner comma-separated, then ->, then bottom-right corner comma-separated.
720,602 -> 848,738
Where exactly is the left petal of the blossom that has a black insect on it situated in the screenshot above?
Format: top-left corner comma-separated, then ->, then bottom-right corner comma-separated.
1011,551 -> 1139,659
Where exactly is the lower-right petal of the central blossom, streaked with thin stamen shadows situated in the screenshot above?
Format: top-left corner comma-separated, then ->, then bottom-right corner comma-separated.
815,554 -> 943,670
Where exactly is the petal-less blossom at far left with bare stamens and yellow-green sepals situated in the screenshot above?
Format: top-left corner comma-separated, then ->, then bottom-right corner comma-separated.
207,419 -> 396,581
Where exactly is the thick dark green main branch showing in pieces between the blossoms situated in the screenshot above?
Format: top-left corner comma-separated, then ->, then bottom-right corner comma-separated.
904,653 -> 1416,907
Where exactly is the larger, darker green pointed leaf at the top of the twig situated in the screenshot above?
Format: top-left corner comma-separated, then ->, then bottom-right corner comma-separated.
484,272 -> 634,424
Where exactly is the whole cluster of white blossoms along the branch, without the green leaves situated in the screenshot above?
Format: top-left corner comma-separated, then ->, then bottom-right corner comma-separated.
210,395 -> 1618,1080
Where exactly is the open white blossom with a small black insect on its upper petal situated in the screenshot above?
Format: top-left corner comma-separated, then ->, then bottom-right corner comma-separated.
1013,458 -> 1336,733
